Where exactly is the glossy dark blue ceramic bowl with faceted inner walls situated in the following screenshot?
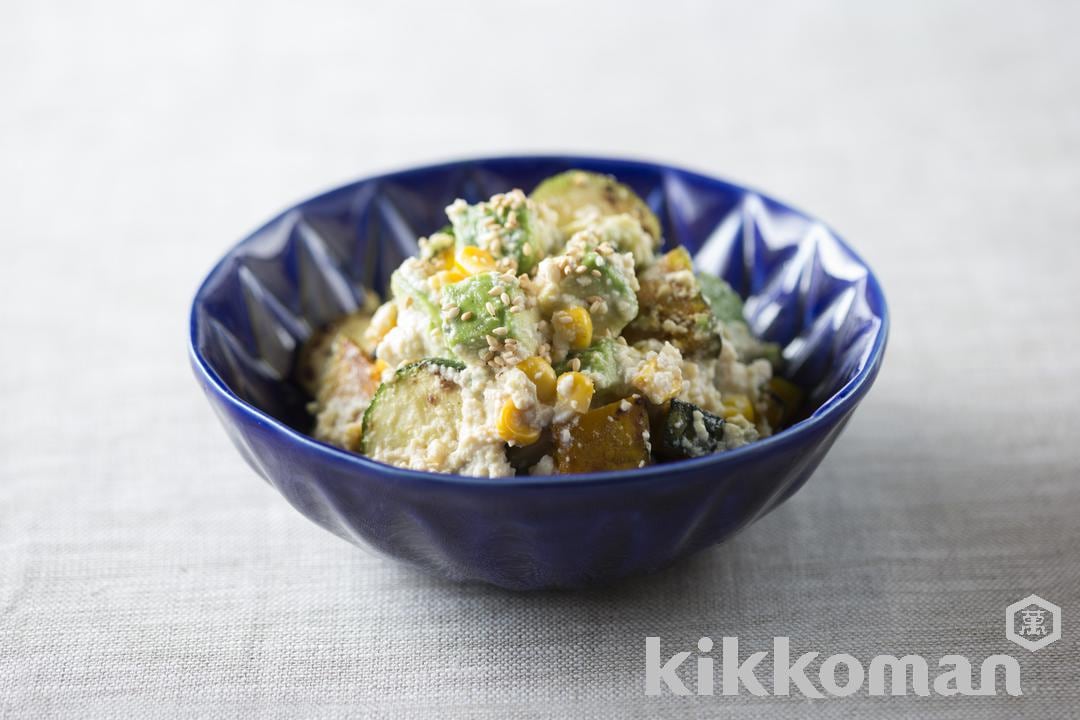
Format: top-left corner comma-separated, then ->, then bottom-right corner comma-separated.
190,157 -> 889,589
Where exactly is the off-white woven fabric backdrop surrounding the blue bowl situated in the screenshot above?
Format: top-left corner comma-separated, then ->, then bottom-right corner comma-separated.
0,0 -> 1080,718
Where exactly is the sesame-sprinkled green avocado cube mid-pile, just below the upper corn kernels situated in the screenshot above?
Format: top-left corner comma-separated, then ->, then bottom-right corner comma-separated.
442,272 -> 540,363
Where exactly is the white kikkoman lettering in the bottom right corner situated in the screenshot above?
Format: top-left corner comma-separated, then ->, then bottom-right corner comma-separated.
645,637 -> 1023,698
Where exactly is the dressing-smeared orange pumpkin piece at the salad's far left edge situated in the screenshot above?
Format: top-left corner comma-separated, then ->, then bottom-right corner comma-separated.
313,334 -> 382,450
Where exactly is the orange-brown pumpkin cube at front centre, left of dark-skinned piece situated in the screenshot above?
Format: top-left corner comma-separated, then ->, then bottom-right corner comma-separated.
552,397 -> 650,474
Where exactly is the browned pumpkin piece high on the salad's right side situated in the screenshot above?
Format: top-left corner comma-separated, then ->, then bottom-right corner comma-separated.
623,247 -> 720,355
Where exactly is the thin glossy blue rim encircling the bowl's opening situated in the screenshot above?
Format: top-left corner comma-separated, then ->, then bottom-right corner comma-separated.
188,153 -> 890,488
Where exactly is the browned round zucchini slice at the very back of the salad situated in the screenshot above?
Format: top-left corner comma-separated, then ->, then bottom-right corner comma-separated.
529,169 -> 661,243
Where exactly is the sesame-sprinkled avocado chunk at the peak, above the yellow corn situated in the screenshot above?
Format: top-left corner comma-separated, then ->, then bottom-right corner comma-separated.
446,190 -> 559,273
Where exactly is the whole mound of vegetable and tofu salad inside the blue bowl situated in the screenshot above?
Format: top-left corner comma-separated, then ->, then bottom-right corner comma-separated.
295,169 -> 802,477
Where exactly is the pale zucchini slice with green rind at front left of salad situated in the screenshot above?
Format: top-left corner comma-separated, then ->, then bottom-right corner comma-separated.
360,358 -> 464,466
